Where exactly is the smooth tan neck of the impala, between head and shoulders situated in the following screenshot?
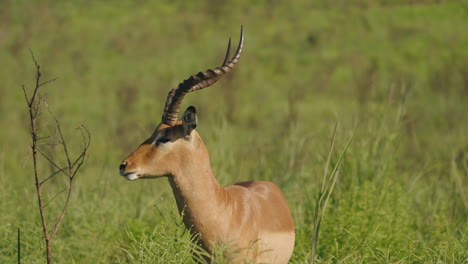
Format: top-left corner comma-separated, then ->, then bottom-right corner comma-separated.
169,135 -> 225,237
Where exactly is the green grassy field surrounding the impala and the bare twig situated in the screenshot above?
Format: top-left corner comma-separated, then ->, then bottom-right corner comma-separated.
0,0 -> 468,263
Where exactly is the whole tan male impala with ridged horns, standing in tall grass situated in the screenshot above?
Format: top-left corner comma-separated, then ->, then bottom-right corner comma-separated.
120,28 -> 295,263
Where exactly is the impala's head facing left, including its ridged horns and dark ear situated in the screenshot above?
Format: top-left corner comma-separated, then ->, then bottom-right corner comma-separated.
120,28 -> 244,180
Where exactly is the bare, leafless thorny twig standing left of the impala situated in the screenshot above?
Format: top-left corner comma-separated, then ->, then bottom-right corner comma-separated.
22,50 -> 91,264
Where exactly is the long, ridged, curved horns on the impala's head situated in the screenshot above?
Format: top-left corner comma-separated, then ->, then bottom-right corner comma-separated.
162,27 -> 244,126
